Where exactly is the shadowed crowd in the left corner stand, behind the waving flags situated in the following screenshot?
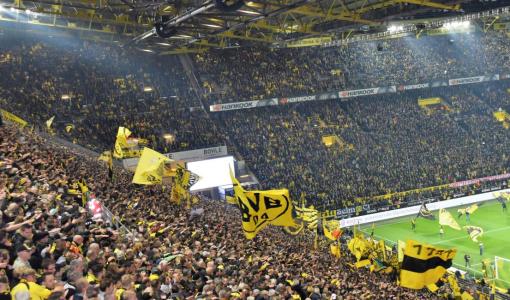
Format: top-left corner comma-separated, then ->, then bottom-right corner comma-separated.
0,32 -> 225,152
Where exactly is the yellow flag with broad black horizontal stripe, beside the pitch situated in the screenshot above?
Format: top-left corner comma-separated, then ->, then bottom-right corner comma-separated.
400,240 -> 457,290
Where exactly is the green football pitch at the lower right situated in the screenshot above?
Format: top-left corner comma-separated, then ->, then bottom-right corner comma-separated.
362,201 -> 510,288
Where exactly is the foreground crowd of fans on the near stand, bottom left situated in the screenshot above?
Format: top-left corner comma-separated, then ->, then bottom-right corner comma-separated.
0,125 -> 447,300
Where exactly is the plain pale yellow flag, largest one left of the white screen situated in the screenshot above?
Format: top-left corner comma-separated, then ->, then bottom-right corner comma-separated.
133,147 -> 171,185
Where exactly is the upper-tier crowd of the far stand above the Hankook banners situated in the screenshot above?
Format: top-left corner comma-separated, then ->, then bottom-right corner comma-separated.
195,32 -> 510,104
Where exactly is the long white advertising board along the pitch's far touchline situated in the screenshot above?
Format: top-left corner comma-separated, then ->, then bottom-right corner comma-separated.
340,189 -> 510,227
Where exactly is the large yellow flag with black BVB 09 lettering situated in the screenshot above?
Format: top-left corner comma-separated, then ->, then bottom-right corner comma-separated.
230,170 -> 295,239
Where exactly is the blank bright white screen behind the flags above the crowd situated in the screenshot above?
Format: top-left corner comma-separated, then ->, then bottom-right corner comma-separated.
187,156 -> 234,191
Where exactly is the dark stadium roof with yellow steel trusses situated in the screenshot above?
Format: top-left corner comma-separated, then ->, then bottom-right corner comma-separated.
0,0 -> 510,54
